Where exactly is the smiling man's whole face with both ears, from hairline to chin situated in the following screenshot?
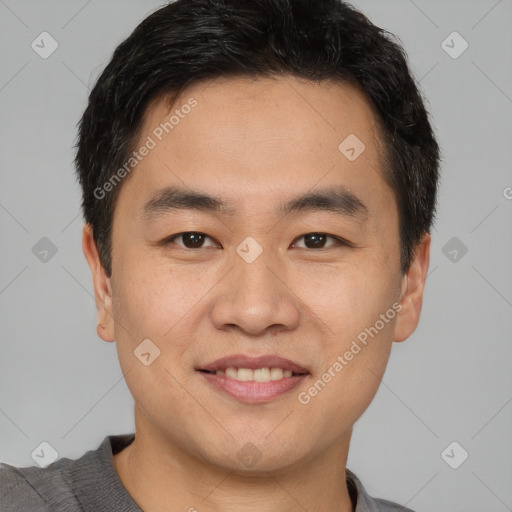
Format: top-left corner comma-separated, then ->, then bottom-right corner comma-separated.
84,77 -> 429,471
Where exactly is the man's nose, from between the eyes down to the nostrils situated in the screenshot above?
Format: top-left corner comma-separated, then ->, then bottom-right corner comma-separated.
211,243 -> 300,336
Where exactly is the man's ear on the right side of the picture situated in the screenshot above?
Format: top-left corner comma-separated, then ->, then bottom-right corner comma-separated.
394,233 -> 432,342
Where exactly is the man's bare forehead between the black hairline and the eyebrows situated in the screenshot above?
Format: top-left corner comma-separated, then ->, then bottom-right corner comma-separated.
116,73 -> 390,224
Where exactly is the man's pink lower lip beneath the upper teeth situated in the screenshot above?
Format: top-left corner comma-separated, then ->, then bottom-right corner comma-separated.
199,372 -> 308,404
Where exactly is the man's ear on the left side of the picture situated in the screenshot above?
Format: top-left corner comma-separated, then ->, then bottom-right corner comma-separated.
82,224 -> 115,341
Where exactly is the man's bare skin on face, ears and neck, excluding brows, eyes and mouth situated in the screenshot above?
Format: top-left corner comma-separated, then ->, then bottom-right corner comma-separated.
83,73 -> 430,512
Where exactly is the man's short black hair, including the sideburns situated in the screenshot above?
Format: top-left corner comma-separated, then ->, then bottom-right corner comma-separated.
75,0 -> 440,276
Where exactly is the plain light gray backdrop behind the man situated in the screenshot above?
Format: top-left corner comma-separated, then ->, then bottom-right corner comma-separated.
0,0 -> 512,512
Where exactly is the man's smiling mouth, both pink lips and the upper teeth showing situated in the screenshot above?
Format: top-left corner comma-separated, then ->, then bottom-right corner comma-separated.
195,355 -> 311,403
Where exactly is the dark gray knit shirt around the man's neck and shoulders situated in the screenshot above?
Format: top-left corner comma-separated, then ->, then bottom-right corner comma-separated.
0,433 -> 413,512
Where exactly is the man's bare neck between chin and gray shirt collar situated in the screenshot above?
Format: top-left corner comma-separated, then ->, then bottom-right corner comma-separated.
114,416 -> 354,512
